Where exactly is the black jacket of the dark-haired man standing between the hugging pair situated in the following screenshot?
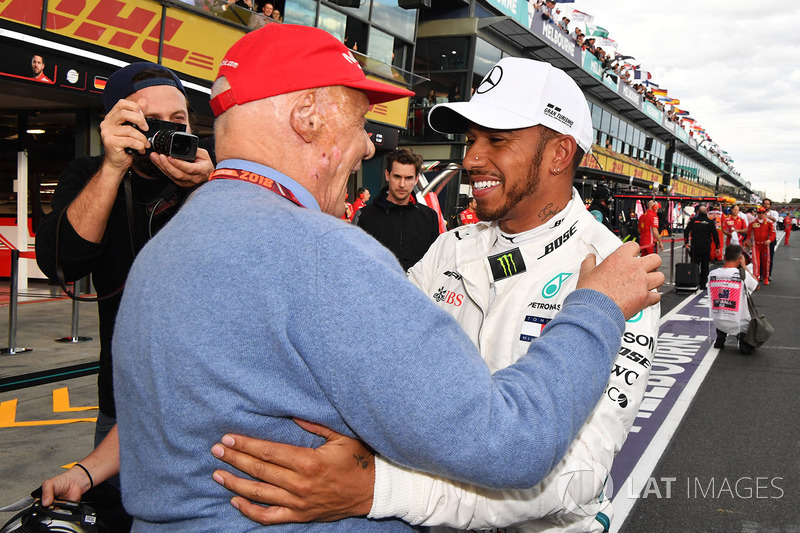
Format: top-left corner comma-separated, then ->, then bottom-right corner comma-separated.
353,187 -> 439,270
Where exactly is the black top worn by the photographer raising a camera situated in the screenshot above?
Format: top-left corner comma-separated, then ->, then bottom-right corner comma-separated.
36,156 -> 188,417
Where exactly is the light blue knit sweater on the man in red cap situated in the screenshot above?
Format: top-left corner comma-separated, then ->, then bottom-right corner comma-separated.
113,163 -> 624,532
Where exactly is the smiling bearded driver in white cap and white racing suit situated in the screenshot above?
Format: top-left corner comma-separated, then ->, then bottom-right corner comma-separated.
209,58 -> 660,533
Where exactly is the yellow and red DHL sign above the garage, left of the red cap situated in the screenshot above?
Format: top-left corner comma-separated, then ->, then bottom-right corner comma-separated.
0,0 -> 244,80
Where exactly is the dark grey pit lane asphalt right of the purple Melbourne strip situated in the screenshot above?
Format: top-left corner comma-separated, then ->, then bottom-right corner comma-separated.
615,232 -> 800,533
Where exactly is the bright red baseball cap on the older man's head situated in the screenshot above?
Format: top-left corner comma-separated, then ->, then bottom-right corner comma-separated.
210,24 -> 414,116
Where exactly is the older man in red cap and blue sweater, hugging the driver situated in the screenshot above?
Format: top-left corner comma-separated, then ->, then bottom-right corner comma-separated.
37,25 -> 663,531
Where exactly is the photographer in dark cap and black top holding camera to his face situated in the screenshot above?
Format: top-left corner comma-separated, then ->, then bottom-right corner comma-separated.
36,62 -> 214,524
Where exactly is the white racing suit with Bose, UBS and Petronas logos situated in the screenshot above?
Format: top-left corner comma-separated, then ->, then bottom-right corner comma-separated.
369,189 -> 660,533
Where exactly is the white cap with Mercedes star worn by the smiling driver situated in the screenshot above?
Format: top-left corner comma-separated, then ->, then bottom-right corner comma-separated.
428,57 -> 594,153
